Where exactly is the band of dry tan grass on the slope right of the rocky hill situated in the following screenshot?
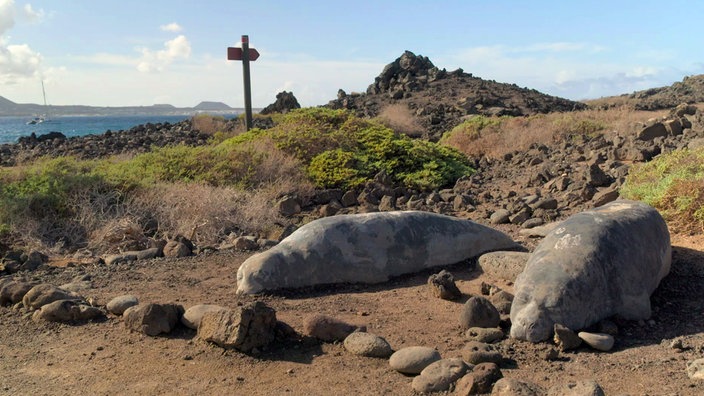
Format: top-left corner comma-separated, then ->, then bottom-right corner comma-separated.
442,107 -> 667,158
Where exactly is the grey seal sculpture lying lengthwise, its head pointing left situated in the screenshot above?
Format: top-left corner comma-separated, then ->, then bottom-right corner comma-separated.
237,211 -> 520,294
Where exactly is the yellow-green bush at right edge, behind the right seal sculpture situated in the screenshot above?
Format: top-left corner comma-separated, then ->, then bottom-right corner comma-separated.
621,148 -> 704,232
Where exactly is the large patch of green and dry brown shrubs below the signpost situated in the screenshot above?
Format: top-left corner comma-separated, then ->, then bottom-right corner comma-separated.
0,108 -> 472,253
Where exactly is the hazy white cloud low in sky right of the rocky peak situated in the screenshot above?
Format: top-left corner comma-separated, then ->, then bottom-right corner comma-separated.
435,42 -> 685,100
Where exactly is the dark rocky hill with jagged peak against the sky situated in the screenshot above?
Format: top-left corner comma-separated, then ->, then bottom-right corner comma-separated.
327,51 -> 586,139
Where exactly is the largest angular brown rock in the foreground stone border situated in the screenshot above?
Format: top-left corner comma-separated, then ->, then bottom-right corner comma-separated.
198,301 -> 277,353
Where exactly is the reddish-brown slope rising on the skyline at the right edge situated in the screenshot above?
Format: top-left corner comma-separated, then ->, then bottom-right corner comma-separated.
586,74 -> 704,110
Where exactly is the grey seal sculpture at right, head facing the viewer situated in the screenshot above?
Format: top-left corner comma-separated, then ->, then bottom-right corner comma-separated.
511,200 -> 672,342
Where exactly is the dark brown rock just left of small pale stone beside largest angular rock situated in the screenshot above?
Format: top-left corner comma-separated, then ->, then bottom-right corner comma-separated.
123,304 -> 183,336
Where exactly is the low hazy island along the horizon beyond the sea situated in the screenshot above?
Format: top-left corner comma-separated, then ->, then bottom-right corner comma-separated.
0,96 -> 248,117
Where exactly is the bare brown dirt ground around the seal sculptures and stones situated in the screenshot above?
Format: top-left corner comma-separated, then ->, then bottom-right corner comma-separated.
0,230 -> 704,395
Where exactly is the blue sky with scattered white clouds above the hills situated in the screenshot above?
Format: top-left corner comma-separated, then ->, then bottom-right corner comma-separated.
0,0 -> 704,107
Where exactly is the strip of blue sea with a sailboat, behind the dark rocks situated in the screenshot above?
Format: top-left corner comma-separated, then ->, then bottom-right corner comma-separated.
0,114 -> 237,144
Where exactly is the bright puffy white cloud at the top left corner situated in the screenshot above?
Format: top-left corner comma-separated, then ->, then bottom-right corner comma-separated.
0,0 -> 42,85
